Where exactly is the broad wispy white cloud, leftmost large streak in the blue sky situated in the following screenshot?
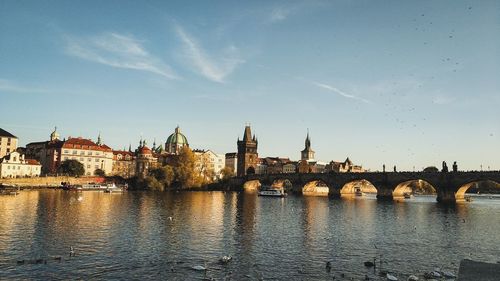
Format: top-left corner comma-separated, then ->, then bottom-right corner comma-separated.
66,33 -> 179,79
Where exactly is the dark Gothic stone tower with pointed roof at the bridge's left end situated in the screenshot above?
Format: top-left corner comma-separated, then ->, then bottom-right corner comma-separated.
237,126 -> 259,177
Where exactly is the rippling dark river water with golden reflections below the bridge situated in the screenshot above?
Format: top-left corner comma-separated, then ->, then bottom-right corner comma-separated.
0,190 -> 500,280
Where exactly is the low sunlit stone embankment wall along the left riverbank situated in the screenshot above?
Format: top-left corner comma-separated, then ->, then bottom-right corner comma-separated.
0,176 -> 106,188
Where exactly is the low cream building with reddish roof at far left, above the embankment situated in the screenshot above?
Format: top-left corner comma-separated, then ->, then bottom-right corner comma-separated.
0,151 -> 42,178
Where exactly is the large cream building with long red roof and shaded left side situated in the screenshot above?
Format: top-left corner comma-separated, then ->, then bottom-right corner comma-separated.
26,128 -> 113,176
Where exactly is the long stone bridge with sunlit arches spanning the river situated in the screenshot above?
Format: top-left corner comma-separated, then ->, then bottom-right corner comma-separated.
231,171 -> 500,203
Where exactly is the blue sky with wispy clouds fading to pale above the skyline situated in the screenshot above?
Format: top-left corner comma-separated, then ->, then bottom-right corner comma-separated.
0,0 -> 500,171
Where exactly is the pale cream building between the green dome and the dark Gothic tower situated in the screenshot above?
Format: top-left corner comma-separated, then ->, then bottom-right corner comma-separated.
193,149 -> 225,181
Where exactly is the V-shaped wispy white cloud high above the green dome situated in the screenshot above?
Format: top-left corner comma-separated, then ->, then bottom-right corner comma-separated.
175,25 -> 245,83
